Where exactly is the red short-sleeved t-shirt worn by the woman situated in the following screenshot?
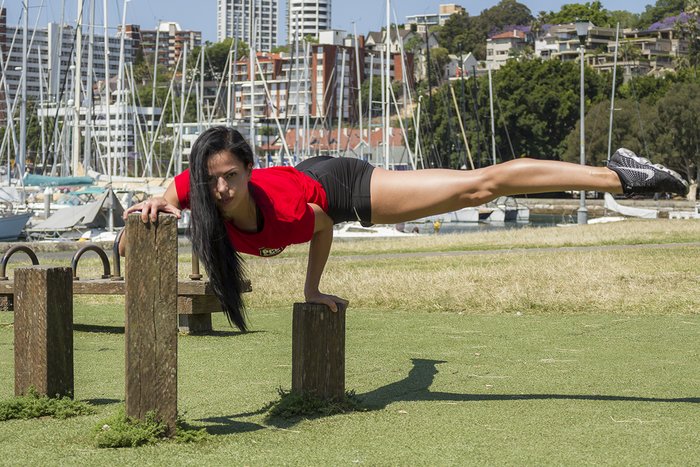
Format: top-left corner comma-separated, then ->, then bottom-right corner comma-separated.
175,167 -> 328,256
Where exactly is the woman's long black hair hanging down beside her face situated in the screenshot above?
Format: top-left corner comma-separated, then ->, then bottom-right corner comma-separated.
187,126 -> 253,331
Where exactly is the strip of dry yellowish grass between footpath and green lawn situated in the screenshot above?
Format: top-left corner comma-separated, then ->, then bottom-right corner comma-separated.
249,247 -> 700,314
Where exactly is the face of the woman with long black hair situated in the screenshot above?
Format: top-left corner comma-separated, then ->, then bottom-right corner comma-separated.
208,151 -> 252,218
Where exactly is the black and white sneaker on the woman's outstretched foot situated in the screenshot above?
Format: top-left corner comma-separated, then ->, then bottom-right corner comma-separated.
608,148 -> 688,196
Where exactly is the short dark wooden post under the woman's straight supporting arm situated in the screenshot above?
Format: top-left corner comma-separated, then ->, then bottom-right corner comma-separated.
292,303 -> 346,400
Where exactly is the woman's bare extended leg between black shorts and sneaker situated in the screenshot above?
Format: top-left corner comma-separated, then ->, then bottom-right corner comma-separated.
371,159 -> 622,224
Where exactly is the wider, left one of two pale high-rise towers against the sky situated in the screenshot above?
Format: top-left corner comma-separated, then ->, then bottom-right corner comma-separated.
216,0 -> 279,52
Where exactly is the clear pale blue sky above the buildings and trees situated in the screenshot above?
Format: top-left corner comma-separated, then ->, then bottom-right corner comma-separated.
5,0 -> 655,43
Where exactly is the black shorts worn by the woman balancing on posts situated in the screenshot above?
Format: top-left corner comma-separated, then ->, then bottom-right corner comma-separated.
295,156 -> 374,227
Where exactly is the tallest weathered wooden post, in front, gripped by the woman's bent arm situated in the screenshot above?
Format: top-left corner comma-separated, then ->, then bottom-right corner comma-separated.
124,213 -> 178,435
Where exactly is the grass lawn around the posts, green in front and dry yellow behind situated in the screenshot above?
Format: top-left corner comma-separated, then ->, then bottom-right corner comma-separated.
0,221 -> 700,465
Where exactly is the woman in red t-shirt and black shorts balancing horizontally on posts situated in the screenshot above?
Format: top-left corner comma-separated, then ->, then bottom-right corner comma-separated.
120,127 -> 688,330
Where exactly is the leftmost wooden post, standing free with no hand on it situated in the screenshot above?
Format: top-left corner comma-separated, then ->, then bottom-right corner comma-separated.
14,266 -> 73,397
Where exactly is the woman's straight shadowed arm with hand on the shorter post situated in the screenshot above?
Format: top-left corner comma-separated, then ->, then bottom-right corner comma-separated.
304,203 -> 348,311
